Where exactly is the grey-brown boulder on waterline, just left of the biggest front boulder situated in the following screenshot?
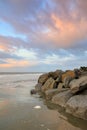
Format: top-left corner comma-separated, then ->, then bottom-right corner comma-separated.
52,90 -> 73,107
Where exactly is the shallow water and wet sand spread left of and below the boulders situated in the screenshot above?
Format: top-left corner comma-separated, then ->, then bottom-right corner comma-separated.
0,74 -> 87,130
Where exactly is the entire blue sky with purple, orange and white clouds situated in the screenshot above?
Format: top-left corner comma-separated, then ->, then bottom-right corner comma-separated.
0,0 -> 87,72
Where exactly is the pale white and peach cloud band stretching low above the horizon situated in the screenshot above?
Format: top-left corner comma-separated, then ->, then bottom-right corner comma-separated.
0,46 -> 87,71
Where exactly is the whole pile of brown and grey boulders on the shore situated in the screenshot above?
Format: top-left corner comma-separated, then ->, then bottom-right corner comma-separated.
33,67 -> 87,120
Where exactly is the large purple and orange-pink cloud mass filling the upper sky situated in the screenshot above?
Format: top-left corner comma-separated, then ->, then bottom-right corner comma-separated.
0,0 -> 87,48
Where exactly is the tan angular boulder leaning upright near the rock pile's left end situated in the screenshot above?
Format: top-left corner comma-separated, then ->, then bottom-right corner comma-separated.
41,78 -> 55,92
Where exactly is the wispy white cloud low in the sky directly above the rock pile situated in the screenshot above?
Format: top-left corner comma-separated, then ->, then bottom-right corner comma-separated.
41,50 -> 87,71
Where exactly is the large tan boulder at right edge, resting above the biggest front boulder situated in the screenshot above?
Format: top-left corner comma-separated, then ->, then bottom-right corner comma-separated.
69,76 -> 87,94
